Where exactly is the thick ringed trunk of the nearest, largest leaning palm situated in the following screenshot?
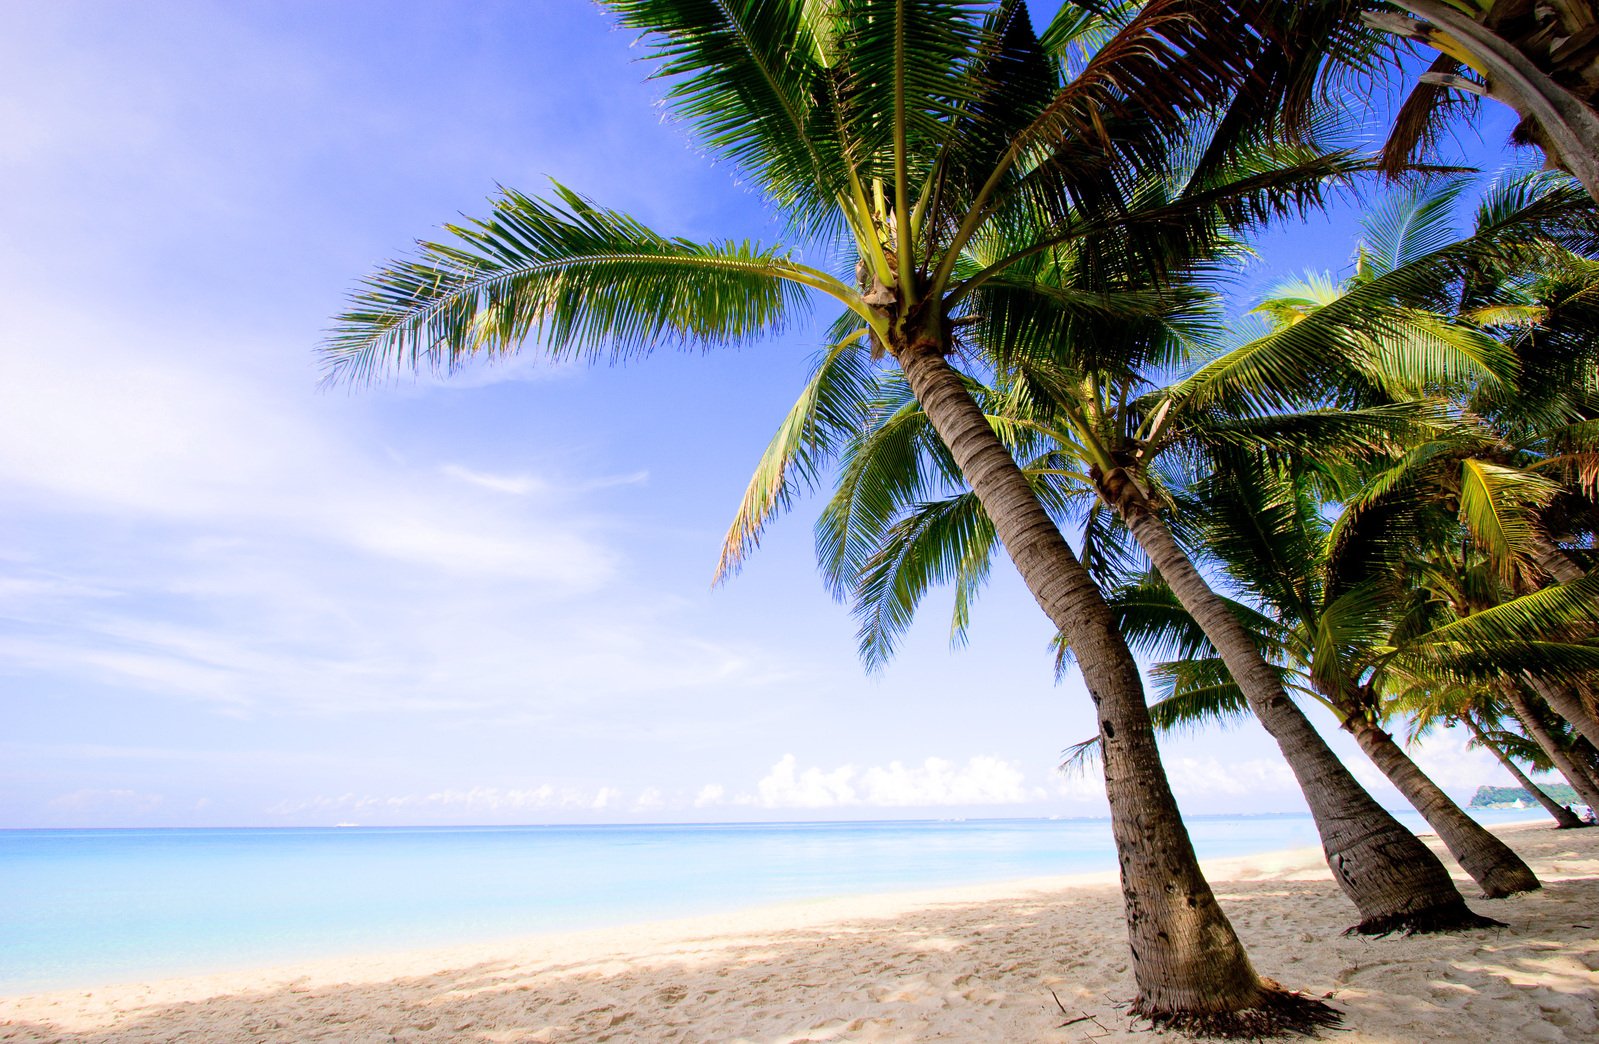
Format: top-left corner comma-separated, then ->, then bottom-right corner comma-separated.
895,342 -> 1330,1022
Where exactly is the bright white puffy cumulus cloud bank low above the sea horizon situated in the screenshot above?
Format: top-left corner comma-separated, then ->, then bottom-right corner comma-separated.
751,755 -> 1046,809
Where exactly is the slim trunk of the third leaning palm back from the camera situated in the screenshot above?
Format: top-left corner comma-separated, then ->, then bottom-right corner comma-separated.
1345,715 -> 1543,899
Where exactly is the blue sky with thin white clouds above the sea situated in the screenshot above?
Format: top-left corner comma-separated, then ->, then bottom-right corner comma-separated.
0,0 -> 1535,827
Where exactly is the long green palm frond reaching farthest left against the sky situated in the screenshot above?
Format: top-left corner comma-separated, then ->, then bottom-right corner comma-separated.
321,185 -> 831,382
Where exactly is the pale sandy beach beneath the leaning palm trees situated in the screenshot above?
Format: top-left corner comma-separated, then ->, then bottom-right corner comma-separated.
0,825 -> 1599,1044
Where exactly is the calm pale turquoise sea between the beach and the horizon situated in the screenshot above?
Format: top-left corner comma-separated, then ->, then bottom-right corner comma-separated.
0,811 -> 1535,993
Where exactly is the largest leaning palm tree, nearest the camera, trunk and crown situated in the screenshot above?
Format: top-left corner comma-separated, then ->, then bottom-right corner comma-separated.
325,0 -> 1368,1028
